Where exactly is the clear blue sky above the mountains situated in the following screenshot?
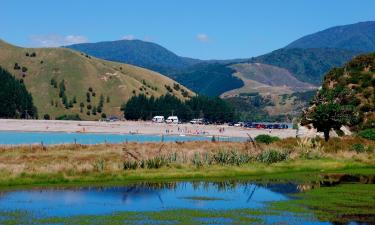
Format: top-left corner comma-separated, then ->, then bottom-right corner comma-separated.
0,0 -> 375,59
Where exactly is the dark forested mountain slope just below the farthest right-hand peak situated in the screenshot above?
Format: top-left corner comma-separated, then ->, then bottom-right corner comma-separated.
249,48 -> 359,85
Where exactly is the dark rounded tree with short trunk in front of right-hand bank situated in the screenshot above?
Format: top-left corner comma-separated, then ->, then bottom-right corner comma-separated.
302,87 -> 359,141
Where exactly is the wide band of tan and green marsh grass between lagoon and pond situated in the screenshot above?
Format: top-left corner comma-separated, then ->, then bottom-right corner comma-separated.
0,137 -> 375,186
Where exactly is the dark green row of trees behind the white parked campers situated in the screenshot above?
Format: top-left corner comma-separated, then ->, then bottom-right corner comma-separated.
121,94 -> 235,122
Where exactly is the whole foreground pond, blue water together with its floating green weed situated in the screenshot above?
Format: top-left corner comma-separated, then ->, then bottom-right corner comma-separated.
0,178 -> 375,224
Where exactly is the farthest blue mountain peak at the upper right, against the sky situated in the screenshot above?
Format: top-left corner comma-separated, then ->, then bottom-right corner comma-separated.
286,21 -> 375,52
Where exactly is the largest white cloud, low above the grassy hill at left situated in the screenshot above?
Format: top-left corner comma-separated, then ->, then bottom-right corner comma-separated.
30,34 -> 88,47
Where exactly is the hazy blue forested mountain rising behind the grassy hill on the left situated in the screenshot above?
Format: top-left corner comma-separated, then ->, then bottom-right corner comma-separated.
66,40 -> 200,73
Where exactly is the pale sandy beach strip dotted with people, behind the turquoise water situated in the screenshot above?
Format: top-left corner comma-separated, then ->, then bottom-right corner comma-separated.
0,119 -> 296,138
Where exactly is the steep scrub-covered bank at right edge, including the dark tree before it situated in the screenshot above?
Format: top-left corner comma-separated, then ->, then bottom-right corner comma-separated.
303,53 -> 375,137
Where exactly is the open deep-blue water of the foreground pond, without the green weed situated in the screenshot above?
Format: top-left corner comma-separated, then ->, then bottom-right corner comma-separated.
0,182 -> 324,224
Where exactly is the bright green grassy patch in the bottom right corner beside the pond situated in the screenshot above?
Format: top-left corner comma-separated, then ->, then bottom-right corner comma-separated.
271,184 -> 375,224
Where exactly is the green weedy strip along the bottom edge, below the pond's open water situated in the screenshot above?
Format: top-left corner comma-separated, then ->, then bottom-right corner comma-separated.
0,209 -> 274,224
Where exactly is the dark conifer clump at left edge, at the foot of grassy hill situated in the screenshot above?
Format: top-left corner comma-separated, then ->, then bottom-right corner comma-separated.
0,67 -> 38,119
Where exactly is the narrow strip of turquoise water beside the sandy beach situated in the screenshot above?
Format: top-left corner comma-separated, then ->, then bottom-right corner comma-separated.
0,132 -> 245,145
